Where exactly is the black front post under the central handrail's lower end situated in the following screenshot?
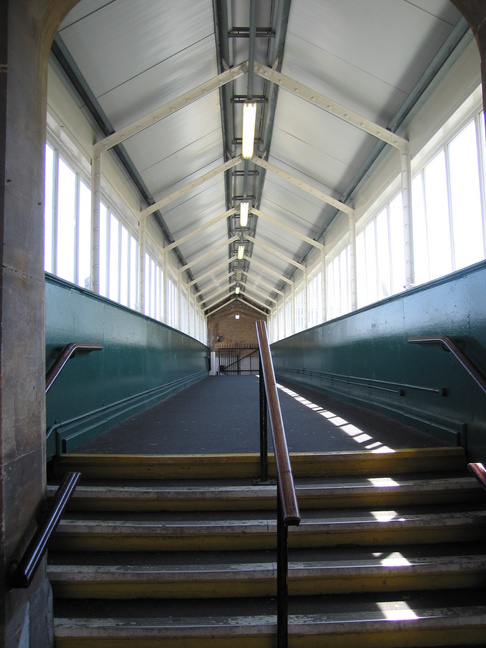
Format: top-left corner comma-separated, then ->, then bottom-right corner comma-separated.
277,482 -> 289,648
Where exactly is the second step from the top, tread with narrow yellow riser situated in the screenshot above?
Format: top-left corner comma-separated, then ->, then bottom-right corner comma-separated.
48,473 -> 486,511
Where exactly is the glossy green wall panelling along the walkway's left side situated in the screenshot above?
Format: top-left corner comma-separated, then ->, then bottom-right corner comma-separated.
46,275 -> 209,459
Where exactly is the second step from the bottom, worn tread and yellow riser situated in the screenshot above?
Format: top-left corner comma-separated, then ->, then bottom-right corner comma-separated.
48,545 -> 486,599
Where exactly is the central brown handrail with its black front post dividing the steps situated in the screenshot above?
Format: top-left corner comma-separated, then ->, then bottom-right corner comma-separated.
256,321 -> 300,648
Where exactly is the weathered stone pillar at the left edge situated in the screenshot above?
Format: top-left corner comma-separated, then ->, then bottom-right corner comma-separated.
0,0 -> 76,648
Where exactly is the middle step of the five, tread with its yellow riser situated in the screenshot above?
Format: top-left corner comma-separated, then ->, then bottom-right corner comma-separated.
50,506 -> 486,551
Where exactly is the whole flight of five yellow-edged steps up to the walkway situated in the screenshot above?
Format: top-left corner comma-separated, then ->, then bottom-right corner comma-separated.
48,447 -> 486,648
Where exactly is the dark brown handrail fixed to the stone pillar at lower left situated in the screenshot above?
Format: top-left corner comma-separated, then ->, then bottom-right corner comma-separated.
8,472 -> 81,587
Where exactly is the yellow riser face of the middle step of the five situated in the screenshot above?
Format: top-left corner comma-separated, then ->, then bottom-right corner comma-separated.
49,525 -> 486,552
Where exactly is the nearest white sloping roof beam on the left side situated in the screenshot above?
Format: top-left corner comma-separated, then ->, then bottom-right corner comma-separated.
93,61 -> 248,155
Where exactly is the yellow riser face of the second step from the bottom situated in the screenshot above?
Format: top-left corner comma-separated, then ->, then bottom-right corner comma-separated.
51,570 -> 486,599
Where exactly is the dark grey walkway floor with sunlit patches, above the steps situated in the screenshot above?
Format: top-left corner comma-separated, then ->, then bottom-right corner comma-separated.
76,376 -> 444,454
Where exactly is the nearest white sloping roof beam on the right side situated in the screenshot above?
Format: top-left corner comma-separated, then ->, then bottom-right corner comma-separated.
254,62 -> 409,152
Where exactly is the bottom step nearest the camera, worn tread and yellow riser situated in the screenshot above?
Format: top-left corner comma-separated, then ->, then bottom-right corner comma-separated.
55,592 -> 486,648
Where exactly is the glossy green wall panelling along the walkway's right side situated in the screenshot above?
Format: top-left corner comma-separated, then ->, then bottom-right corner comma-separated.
272,262 -> 486,461
